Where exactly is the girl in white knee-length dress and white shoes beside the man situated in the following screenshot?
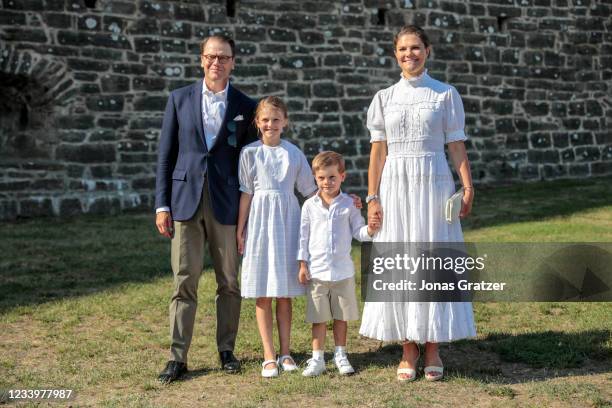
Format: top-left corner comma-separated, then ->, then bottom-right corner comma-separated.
237,96 -> 317,377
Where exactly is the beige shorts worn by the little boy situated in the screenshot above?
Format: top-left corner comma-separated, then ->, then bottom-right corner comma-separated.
306,277 -> 359,323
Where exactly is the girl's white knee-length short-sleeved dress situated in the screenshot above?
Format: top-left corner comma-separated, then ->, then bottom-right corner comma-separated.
239,140 -> 317,298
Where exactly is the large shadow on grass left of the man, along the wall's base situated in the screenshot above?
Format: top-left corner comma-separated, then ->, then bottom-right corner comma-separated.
0,214 -> 209,314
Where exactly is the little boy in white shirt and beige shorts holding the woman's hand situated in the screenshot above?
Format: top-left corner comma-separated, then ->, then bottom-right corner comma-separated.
298,151 -> 380,377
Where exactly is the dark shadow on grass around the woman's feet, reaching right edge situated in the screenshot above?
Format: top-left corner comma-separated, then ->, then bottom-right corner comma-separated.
351,330 -> 612,384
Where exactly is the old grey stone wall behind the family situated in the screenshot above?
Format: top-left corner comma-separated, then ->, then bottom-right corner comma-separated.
0,0 -> 612,219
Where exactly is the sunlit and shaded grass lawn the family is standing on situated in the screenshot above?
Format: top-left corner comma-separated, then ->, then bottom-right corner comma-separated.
0,178 -> 612,407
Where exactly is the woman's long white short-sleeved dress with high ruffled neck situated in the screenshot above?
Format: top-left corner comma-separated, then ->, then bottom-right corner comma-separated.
359,72 -> 476,343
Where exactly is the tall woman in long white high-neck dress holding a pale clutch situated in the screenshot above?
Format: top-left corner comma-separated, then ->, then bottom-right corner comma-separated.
360,26 -> 476,381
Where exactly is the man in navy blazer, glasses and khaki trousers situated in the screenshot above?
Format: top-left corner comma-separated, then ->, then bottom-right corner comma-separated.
155,35 -> 257,383
